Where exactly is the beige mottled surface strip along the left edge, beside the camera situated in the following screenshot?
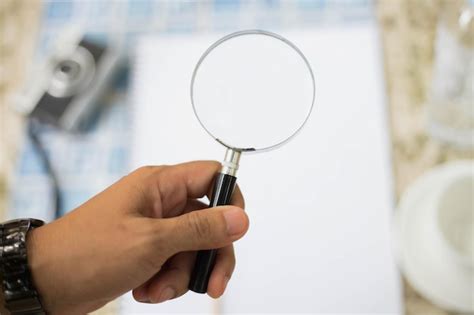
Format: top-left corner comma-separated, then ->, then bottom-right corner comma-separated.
0,0 -> 41,225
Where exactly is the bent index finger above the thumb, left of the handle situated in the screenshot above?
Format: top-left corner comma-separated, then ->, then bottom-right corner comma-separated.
142,161 -> 220,217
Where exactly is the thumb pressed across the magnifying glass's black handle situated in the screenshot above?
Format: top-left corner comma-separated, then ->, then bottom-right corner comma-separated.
160,206 -> 249,253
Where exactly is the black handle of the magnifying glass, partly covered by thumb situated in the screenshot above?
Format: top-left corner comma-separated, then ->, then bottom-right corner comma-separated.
189,173 -> 237,293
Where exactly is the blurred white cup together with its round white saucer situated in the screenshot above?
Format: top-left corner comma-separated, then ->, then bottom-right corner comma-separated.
394,160 -> 474,314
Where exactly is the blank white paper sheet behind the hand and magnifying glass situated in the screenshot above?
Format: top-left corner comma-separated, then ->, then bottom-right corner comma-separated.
122,25 -> 401,314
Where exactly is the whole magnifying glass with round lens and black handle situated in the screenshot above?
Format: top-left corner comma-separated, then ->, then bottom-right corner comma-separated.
189,30 -> 315,293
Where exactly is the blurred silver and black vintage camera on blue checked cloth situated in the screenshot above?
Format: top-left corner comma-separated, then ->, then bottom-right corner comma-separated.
17,35 -> 122,131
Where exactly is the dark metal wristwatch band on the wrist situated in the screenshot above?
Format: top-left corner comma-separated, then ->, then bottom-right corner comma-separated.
0,219 -> 46,315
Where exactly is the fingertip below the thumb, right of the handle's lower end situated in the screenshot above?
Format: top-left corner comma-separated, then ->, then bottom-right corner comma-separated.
207,245 -> 235,299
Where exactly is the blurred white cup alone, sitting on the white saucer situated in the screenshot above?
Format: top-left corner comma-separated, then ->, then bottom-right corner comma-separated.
436,173 -> 474,268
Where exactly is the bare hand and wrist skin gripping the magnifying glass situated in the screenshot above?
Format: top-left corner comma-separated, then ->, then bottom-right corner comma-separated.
23,161 -> 249,314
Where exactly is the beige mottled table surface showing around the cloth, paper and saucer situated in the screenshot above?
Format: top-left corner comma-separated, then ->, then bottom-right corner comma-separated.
0,0 -> 474,315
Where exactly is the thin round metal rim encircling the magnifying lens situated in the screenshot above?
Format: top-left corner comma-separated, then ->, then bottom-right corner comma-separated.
190,29 -> 316,152
